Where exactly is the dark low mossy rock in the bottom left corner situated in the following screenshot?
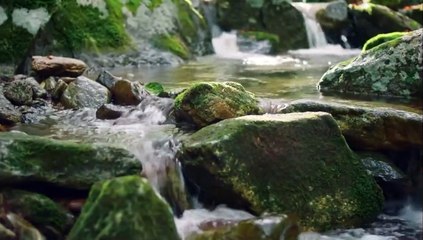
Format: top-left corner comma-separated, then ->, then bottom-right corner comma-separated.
0,189 -> 72,238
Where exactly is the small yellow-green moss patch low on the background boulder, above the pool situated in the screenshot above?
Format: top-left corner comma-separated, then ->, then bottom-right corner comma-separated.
153,35 -> 191,60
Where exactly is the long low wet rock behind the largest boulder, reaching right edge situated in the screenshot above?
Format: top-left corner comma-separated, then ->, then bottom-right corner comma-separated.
280,100 -> 423,150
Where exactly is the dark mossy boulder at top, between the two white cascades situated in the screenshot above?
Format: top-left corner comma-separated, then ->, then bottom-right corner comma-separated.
216,0 -> 308,52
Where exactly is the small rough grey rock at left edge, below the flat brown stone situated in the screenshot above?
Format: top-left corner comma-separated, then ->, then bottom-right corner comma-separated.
3,80 -> 34,106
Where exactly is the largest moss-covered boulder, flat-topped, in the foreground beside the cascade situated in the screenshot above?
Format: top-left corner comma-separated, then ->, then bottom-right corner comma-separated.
178,112 -> 383,230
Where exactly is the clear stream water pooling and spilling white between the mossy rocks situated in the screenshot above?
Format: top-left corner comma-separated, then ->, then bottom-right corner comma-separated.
14,3 -> 423,240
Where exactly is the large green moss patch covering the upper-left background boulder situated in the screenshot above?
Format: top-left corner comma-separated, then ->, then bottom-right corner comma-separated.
52,0 -> 130,52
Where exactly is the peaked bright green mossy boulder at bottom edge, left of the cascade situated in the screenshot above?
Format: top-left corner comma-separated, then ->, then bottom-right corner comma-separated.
67,176 -> 179,240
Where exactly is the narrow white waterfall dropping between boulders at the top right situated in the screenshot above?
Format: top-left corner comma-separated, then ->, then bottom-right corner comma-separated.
292,3 -> 328,48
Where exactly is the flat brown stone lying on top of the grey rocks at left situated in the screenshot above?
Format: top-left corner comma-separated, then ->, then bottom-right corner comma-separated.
32,56 -> 87,77
